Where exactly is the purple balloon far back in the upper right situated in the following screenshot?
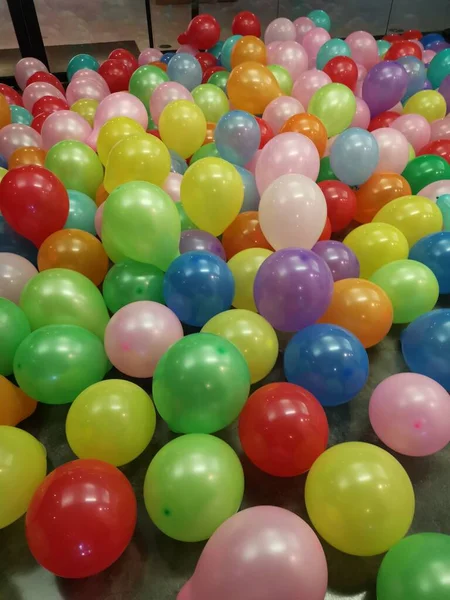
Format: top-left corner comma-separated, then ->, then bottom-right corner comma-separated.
362,61 -> 408,117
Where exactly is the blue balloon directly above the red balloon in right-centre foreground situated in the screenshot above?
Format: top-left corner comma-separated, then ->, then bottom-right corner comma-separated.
284,324 -> 369,406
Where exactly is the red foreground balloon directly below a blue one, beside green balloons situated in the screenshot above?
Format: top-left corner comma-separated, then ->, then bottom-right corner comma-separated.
239,383 -> 328,477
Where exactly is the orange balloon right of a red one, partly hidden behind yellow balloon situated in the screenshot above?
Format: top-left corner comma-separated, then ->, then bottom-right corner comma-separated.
354,173 -> 412,223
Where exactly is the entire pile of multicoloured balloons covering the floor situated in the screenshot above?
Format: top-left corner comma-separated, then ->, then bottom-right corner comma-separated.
0,10 -> 450,600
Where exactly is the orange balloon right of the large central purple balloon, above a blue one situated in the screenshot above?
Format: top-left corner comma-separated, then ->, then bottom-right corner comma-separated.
319,279 -> 393,348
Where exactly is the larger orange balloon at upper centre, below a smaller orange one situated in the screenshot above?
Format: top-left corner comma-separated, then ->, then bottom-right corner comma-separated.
227,62 -> 282,115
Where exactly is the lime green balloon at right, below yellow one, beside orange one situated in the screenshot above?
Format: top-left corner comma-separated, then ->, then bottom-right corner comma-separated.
369,259 -> 439,323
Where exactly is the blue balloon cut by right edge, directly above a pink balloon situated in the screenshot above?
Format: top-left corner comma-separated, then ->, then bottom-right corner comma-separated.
400,308 -> 450,391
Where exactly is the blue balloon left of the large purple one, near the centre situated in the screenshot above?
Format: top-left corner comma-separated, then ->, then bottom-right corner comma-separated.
163,251 -> 234,327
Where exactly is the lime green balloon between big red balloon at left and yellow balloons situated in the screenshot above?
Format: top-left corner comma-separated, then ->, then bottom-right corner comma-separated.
45,140 -> 103,199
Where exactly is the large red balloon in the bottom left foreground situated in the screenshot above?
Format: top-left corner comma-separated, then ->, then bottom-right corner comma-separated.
25,459 -> 136,579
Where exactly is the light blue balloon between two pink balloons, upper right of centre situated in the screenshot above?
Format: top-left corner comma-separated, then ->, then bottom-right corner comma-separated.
330,127 -> 380,185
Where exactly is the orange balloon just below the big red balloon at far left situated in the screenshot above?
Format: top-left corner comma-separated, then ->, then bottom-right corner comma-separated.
38,229 -> 109,285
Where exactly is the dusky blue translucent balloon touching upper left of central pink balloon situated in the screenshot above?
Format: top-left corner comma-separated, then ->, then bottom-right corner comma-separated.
214,110 -> 261,167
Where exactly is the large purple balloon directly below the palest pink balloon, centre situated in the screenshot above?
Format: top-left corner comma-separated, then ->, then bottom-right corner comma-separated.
253,248 -> 333,331
